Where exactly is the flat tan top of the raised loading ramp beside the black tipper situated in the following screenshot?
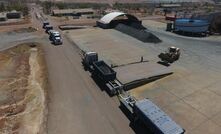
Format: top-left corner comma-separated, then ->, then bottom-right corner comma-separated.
114,62 -> 172,88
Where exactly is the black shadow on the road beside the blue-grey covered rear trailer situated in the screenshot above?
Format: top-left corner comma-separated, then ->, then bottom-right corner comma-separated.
119,106 -> 153,134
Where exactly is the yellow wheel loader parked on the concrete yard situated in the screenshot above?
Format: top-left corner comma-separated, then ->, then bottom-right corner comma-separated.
158,46 -> 180,63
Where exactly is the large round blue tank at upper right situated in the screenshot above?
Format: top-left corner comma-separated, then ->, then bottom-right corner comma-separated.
174,19 -> 209,33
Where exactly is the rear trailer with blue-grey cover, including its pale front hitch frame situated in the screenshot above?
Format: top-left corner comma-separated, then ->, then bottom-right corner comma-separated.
119,94 -> 185,134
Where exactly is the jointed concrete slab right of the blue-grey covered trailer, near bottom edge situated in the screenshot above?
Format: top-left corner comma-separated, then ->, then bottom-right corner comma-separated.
164,100 -> 207,132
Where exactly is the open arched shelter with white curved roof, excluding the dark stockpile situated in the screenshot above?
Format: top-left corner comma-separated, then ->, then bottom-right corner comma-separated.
97,12 -> 141,29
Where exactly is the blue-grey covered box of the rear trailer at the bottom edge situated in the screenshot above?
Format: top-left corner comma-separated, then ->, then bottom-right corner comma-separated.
135,99 -> 184,134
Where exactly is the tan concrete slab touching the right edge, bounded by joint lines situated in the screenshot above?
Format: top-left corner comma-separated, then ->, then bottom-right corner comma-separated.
184,89 -> 221,118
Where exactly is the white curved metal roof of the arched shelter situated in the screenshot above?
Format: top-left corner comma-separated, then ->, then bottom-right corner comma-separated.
99,12 -> 138,24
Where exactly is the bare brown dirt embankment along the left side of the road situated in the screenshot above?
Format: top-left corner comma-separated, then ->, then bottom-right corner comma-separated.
0,43 -> 47,134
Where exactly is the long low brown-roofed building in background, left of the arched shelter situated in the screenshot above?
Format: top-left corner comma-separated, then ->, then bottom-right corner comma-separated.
52,8 -> 95,16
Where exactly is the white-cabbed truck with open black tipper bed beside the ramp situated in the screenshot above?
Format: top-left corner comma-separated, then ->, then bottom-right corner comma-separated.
82,52 -> 123,96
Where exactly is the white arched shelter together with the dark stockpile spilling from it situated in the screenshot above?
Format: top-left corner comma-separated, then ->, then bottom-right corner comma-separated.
97,12 -> 161,43
